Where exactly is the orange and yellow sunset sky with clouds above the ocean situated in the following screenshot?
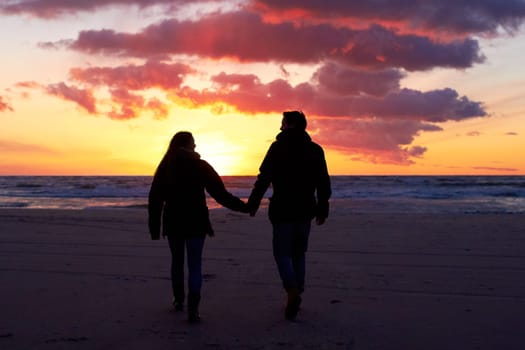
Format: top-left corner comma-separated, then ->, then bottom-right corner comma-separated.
0,0 -> 525,175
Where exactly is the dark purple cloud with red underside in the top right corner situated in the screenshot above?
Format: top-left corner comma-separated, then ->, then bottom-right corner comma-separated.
253,0 -> 525,34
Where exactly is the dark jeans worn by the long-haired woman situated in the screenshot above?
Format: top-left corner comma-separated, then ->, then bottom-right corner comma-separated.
168,236 -> 204,302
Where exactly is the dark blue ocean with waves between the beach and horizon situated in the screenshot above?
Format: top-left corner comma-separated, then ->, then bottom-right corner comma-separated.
0,176 -> 525,213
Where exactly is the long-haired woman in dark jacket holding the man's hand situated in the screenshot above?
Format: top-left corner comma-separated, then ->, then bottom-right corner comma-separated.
148,131 -> 247,322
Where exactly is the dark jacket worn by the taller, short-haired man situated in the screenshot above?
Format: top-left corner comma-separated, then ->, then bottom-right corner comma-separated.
248,129 -> 332,223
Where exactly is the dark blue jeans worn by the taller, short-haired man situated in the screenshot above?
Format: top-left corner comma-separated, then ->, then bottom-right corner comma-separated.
273,220 -> 311,292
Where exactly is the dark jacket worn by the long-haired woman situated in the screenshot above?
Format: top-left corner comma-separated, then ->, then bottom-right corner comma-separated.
148,149 -> 246,239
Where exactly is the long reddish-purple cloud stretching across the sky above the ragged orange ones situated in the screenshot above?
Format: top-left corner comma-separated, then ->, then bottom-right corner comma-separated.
70,11 -> 484,70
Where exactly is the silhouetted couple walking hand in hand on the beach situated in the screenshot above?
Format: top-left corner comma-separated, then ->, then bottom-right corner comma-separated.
148,111 -> 331,322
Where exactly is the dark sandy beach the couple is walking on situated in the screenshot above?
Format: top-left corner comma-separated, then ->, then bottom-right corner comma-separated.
0,203 -> 525,350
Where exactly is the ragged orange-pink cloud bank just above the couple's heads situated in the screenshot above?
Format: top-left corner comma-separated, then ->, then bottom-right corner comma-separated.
35,58 -> 487,165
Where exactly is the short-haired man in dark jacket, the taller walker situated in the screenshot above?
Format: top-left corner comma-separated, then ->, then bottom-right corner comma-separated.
248,111 -> 332,320
